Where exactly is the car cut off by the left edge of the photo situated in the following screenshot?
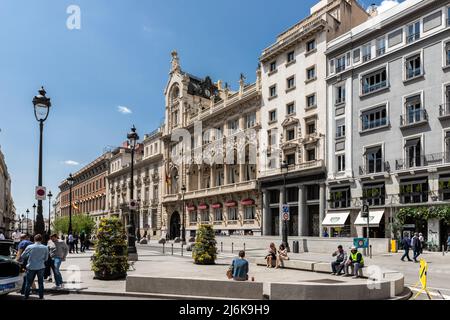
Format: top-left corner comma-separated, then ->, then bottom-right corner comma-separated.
0,240 -> 23,296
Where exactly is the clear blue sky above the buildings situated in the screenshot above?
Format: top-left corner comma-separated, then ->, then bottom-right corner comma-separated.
0,0 -> 389,218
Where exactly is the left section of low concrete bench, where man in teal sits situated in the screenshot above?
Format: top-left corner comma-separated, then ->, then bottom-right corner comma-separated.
125,275 -> 263,300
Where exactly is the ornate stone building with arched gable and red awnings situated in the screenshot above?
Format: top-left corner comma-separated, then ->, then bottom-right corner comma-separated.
162,52 -> 261,239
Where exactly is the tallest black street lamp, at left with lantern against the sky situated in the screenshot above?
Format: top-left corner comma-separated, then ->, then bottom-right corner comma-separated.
33,87 -> 52,234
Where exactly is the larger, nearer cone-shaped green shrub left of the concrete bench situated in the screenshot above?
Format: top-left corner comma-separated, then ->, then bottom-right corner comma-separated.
92,218 -> 129,280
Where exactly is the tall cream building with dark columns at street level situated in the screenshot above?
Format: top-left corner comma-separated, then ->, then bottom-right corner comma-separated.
259,0 -> 368,236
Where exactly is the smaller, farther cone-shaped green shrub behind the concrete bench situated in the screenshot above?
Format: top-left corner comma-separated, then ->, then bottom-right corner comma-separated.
192,225 -> 217,265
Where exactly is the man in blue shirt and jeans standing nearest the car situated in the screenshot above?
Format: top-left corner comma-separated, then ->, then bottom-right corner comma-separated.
22,234 -> 48,300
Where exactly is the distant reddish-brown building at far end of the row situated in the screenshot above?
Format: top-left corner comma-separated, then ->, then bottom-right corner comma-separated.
57,152 -> 111,224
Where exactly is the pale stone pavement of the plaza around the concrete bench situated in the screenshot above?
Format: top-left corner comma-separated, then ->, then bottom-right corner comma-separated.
36,243 -> 450,299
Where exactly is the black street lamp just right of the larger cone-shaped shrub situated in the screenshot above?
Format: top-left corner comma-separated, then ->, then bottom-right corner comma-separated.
127,125 -> 139,261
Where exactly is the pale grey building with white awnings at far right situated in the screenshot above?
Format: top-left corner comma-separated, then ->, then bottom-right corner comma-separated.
323,0 -> 450,248
